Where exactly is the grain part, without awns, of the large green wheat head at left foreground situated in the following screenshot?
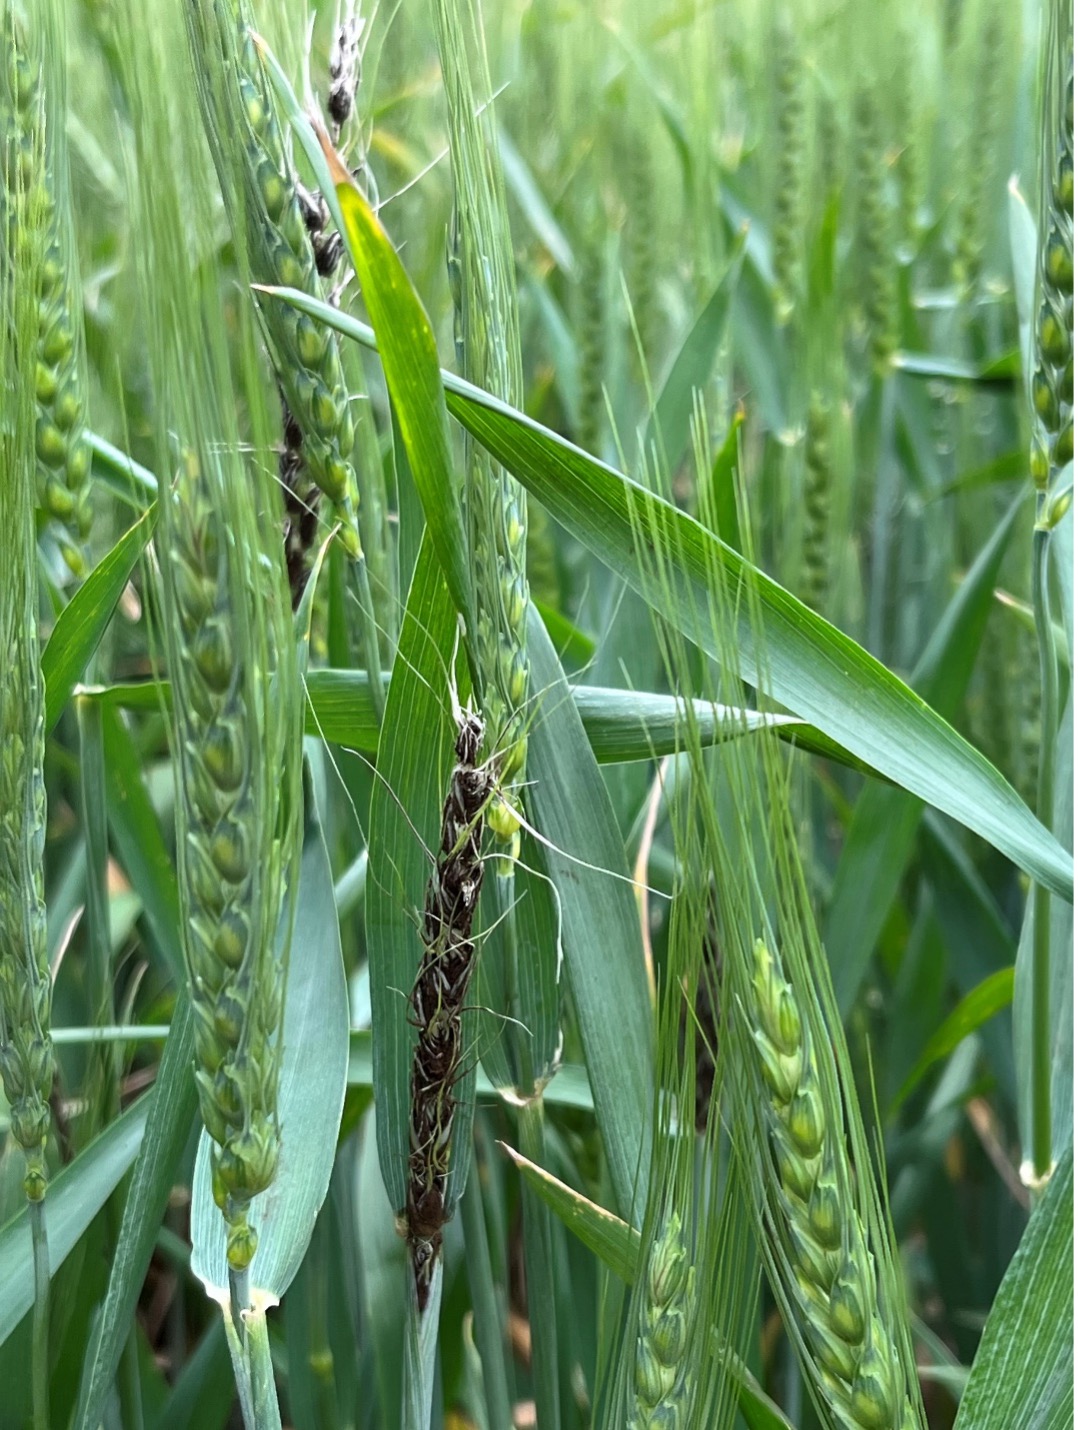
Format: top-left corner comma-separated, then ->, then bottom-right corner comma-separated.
162,443 -> 300,1270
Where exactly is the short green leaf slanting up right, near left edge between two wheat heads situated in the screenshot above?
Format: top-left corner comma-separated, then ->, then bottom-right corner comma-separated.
41,506 -> 157,734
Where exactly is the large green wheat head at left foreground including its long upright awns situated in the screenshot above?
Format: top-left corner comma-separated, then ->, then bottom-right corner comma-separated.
119,0 -> 302,1271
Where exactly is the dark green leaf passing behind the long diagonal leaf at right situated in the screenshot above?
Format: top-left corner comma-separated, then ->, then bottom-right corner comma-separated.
824,496 -> 1024,1017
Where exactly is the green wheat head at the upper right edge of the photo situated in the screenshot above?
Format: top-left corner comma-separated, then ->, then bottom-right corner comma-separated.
1029,4 -> 1074,490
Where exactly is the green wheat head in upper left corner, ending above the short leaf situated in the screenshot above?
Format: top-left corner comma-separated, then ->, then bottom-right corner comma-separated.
0,4 -> 93,575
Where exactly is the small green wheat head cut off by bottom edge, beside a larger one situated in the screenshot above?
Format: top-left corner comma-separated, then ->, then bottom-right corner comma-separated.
629,1211 -> 696,1430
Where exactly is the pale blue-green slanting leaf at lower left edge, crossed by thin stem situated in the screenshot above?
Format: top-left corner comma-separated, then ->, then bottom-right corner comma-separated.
0,1094 -> 150,1343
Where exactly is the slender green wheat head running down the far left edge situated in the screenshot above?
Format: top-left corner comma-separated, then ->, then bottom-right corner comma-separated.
0,72 -> 53,1201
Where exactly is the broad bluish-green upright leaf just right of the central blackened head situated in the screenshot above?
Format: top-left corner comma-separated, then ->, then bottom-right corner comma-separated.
528,611 -> 653,1217
